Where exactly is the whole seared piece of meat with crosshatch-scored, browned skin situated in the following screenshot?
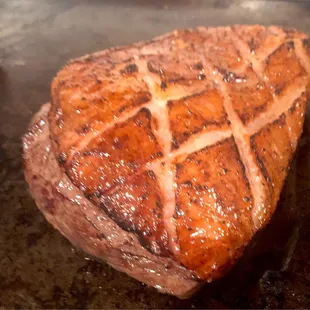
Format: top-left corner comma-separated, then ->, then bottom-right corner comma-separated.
23,25 -> 310,298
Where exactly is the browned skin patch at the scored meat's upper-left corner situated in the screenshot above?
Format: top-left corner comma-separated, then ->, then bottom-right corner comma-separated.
51,62 -> 151,159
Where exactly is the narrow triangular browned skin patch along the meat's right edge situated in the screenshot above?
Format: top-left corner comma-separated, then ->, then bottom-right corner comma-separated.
251,93 -> 307,221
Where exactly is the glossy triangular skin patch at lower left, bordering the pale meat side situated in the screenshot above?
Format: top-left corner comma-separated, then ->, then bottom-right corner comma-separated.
99,171 -> 170,256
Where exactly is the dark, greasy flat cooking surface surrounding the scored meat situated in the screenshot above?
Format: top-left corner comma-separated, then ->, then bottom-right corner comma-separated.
0,0 -> 310,308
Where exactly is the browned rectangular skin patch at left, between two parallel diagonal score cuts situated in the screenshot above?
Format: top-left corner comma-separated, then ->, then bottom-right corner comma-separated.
66,109 -> 162,195
